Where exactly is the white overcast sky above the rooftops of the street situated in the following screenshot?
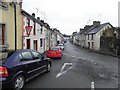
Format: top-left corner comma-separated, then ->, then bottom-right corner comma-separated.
23,0 -> 119,35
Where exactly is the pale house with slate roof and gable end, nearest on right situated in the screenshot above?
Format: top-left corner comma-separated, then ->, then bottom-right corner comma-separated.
86,22 -> 114,50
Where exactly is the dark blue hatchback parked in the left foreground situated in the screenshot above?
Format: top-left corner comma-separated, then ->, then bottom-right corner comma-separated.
0,49 -> 52,90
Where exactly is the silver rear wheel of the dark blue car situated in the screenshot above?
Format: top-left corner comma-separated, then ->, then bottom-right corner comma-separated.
13,75 -> 25,90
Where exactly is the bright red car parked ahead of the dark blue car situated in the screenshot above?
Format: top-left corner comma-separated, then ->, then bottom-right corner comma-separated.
46,46 -> 62,58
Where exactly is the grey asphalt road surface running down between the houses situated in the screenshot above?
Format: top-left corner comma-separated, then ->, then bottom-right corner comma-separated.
24,41 -> 119,90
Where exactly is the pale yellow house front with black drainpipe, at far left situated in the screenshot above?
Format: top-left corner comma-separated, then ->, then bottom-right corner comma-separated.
0,0 -> 22,49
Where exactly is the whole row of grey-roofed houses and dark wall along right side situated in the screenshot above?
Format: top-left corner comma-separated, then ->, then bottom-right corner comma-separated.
71,21 -> 120,55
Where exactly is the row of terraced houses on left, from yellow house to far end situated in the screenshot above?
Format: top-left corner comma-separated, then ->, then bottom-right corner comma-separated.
0,0 -> 64,53
